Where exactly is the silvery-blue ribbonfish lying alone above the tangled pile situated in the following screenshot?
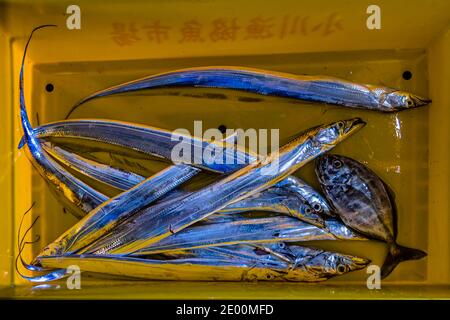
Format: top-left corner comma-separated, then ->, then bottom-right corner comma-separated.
66,66 -> 431,119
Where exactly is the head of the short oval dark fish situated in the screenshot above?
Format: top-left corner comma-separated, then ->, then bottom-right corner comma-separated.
315,154 -> 354,188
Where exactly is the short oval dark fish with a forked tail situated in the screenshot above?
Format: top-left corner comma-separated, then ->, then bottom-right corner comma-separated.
316,154 -> 427,278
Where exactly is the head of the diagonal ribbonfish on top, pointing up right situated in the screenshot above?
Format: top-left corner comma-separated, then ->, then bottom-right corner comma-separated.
309,118 -> 366,152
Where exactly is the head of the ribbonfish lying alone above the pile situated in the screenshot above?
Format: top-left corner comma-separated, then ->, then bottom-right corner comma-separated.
380,90 -> 431,111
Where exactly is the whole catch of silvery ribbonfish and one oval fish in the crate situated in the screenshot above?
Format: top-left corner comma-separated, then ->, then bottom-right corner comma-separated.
18,26 -> 429,282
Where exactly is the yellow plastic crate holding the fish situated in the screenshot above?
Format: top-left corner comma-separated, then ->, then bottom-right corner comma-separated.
0,0 -> 450,299
